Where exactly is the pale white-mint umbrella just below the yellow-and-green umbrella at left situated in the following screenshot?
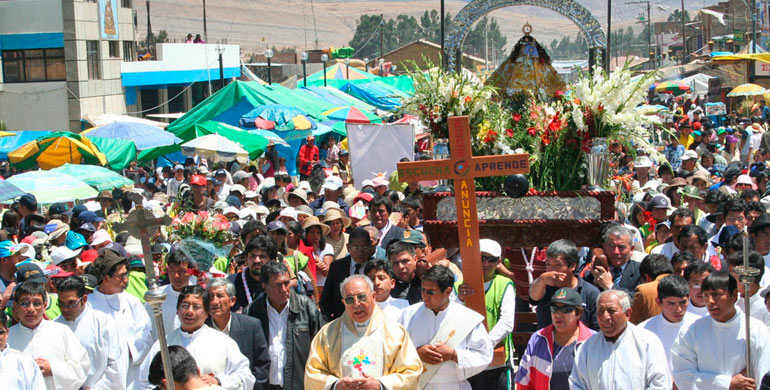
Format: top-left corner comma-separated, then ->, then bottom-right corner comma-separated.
6,170 -> 99,204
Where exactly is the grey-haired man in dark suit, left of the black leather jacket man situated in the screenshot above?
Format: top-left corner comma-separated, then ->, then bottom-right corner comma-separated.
206,278 -> 270,390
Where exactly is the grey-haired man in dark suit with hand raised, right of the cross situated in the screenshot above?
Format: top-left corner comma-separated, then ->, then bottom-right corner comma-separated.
584,224 -> 642,298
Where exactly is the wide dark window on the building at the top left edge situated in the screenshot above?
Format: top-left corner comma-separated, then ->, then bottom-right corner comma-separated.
3,48 -> 67,83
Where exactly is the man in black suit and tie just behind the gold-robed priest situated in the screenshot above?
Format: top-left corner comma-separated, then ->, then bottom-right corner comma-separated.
318,227 -> 375,322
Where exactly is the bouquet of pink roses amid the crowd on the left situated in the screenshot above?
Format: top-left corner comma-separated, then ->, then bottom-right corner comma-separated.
169,211 -> 236,247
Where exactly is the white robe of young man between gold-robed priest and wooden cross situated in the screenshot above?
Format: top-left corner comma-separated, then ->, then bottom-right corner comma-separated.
399,302 -> 494,390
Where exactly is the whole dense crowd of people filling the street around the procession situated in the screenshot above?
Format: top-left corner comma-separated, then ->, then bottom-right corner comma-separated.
0,101 -> 770,390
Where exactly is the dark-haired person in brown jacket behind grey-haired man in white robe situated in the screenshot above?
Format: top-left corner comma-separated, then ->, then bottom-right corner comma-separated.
630,255 -> 674,325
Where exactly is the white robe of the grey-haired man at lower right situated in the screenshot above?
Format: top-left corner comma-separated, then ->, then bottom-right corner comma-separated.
569,322 -> 671,390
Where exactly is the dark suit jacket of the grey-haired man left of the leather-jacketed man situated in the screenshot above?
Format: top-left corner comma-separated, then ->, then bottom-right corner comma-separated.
206,313 -> 270,390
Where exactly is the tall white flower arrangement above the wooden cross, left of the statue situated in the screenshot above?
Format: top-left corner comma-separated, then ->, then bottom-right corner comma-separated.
401,60 -> 496,139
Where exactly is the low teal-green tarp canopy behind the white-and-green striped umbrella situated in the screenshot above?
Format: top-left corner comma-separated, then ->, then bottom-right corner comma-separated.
138,121 -> 267,161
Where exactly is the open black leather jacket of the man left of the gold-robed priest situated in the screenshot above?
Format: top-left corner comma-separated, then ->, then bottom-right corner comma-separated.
244,291 -> 324,390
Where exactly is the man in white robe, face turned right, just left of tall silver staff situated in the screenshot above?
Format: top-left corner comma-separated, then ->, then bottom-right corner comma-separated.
88,248 -> 153,389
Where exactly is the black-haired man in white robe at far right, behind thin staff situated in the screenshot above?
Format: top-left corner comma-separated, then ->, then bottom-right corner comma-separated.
671,271 -> 770,390
